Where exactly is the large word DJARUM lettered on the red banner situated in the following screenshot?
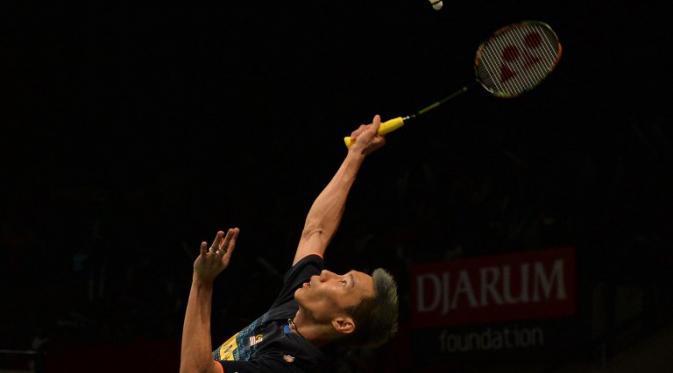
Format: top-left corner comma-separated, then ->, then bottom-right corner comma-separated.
416,259 -> 567,315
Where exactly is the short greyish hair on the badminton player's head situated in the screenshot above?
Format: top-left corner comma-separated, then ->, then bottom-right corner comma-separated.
344,268 -> 399,347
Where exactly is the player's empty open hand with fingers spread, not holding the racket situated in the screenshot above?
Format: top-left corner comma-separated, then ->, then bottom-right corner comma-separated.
194,228 -> 240,282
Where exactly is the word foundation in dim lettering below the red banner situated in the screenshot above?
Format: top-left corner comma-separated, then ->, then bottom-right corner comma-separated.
439,327 -> 544,352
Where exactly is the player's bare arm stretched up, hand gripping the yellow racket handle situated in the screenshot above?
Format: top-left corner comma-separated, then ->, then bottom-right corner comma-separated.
292,115 -> 385,265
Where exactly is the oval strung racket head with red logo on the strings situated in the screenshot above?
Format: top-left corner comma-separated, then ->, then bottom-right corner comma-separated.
474,21 -> 563,98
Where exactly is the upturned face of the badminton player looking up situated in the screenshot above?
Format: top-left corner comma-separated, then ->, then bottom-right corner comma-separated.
294,270 -> 374,322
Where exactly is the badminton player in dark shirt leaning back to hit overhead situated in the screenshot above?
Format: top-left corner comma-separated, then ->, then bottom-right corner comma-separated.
180,115 -> 398,373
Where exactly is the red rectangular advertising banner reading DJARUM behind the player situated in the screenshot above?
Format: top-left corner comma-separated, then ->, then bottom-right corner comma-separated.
411,247 -> 576,328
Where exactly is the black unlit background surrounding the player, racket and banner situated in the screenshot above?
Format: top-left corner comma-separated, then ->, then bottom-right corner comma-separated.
0,0 -> 673,371
